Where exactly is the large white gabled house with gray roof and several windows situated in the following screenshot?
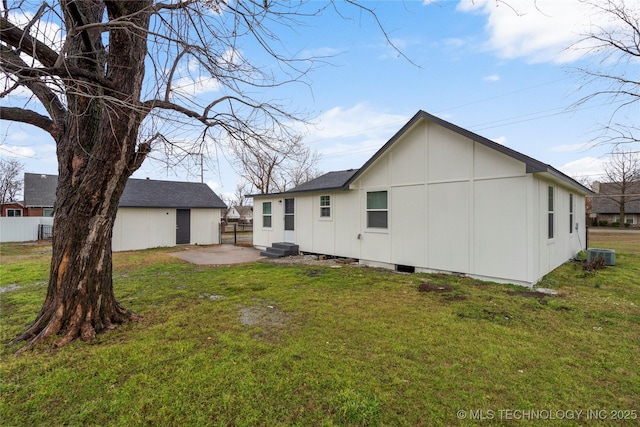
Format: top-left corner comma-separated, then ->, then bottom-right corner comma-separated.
252,111 -> 591,286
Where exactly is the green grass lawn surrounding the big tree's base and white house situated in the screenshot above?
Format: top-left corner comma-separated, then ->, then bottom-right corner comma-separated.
0,233 -> 640,426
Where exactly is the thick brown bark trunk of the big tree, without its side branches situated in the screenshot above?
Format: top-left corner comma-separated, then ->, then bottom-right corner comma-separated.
14,0 -> 151,349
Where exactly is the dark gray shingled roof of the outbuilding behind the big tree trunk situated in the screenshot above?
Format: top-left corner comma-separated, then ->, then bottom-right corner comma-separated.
24,173 -> 227,209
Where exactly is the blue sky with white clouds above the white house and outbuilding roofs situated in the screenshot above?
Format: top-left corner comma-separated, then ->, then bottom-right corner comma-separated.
0,0 -> 640,201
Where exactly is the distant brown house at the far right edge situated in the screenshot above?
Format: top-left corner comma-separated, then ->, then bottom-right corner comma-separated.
591,181 -> 640,227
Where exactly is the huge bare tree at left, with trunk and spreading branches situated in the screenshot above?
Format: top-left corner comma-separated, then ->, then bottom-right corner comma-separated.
0,0 -> 392,350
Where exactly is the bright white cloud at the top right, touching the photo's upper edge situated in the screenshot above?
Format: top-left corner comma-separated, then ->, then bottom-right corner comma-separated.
458,0 -> 608,63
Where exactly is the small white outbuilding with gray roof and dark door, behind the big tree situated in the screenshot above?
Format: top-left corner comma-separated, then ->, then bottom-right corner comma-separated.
11,174 -> 226,251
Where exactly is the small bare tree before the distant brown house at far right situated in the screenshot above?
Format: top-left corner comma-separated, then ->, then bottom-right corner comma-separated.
600,149 -> 640,223
